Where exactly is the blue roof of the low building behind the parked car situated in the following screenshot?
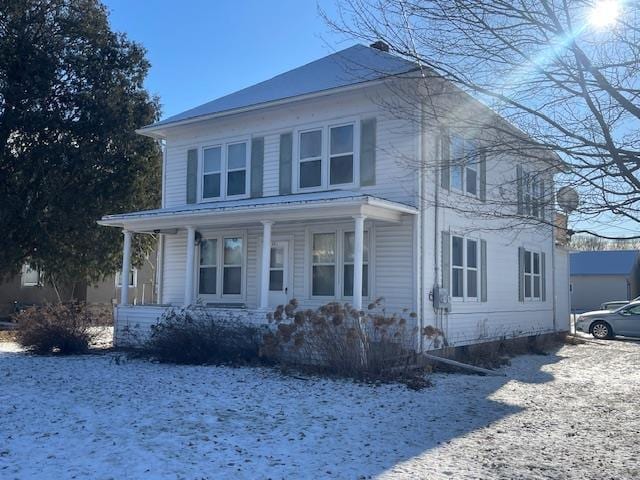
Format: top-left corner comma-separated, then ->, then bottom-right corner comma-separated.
570,250 -> 638,275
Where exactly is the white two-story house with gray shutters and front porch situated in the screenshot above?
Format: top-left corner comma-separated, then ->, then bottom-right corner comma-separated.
100,45 -> 569,345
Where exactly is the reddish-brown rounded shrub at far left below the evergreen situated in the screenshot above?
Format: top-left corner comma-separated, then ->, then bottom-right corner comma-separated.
15,302 -> 106,355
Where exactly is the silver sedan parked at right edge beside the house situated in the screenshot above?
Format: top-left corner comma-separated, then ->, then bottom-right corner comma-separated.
576,301 -> 640,339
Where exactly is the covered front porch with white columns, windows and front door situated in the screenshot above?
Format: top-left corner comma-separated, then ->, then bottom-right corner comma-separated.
100,191 -> 417,344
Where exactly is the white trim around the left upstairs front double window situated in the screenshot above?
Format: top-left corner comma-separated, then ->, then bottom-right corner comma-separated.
198,137 -> 252,203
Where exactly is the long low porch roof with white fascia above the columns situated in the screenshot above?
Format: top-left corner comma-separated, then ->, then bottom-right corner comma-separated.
98,190 -> 418,232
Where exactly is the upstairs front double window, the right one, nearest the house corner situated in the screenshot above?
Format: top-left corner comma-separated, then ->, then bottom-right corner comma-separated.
297,123 -> 357,190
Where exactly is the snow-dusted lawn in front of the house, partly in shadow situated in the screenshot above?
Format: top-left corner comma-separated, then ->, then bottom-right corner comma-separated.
0,341 -> 640,480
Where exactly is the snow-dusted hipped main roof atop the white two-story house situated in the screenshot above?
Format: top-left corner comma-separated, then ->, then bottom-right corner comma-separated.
145,45 -> 417,128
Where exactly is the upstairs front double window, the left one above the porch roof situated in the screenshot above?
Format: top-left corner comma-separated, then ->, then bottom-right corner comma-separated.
202,142 -> 248,200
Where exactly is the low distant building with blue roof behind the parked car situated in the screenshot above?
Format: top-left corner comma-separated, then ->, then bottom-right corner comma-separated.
570,250 -> 640,312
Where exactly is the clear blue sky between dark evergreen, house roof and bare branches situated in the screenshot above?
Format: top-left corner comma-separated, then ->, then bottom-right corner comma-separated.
104,0 -> 344,117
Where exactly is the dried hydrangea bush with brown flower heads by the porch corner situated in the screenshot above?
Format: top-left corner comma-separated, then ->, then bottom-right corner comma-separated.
262,299 -> 439,384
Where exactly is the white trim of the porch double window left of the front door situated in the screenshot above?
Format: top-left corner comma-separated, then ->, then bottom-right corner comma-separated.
193,230 -> 247,303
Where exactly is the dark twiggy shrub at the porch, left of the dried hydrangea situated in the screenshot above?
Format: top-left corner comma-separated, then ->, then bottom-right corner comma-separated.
142,308 -> 261,365
